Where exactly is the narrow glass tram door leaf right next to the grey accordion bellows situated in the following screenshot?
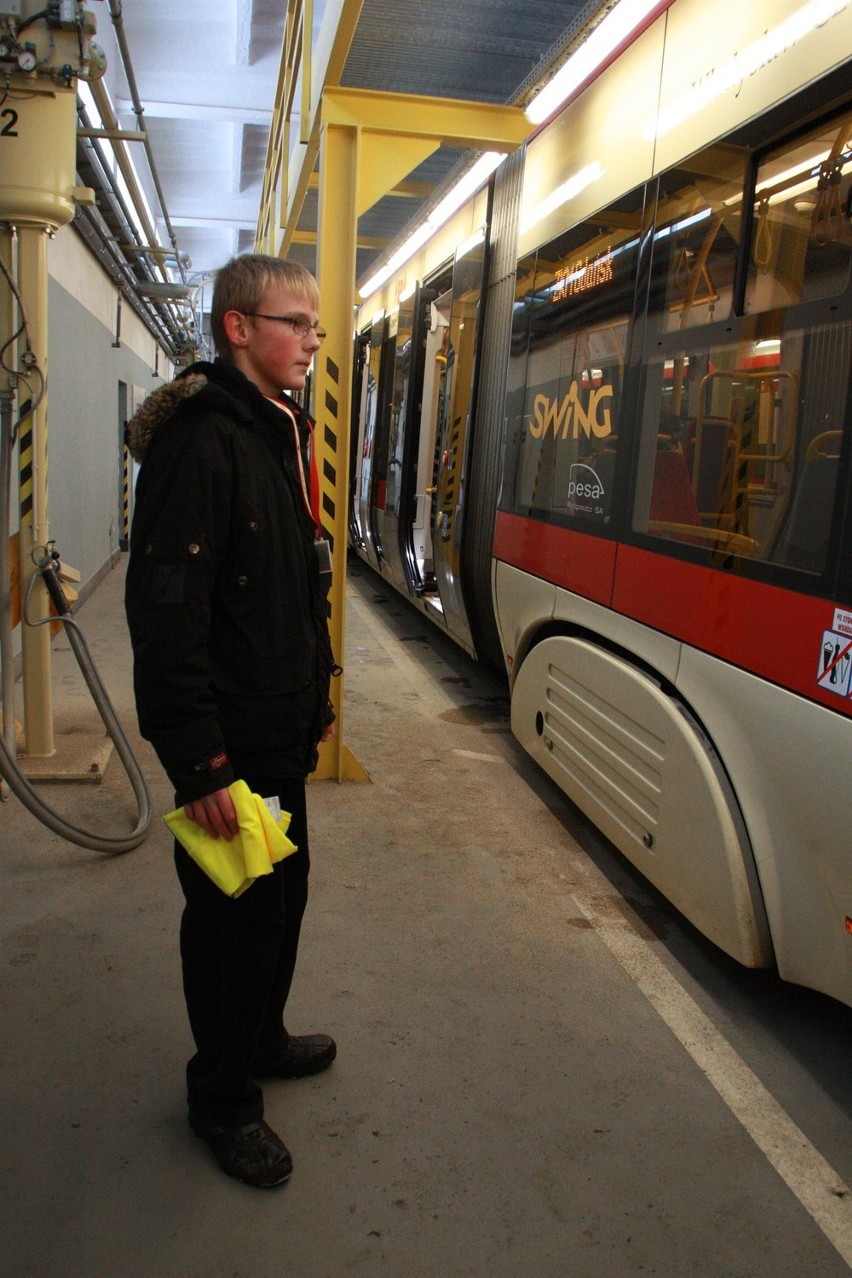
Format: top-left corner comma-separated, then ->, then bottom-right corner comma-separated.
432,233 -> 484,651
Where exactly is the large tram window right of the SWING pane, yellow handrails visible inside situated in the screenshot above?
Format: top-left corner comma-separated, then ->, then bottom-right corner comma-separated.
634,116 -> 852,585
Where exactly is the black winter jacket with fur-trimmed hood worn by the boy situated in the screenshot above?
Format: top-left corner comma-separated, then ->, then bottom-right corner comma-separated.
125,360 -> 333,804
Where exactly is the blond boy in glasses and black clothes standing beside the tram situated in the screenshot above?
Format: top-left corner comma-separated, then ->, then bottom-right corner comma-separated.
125,256 -> 336,1187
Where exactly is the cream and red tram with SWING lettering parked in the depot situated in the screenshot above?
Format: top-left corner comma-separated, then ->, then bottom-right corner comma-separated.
350,0 -> 852,1005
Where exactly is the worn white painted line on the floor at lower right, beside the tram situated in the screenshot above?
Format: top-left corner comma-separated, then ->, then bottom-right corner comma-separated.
572,889 -> 852,1268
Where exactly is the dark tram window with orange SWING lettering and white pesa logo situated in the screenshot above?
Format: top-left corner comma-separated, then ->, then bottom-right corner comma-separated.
503,190 -> 643,529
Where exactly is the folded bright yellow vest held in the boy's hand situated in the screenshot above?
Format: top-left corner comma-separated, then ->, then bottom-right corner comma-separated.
164,781 -> 296,897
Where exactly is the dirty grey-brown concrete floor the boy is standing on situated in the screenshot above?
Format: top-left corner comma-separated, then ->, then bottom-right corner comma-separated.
0,565 -> 852,1278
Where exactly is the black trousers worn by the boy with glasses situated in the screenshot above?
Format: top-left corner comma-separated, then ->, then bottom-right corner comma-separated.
175,776 -> 310,1125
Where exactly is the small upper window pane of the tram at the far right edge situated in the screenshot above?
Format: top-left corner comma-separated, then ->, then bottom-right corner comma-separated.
745,112 -> 852,314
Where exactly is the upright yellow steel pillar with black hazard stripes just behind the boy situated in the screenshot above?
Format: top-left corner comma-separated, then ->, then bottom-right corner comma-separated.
314,115 -> 369,781
